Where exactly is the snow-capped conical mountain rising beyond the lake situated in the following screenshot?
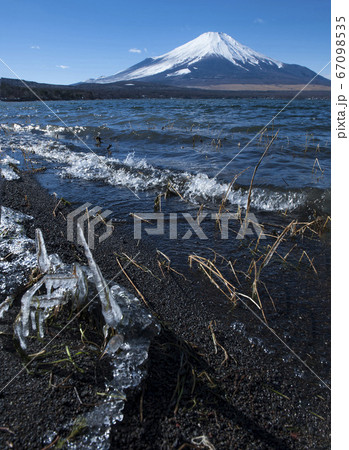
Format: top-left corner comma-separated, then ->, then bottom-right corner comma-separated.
86,32 -> 330,87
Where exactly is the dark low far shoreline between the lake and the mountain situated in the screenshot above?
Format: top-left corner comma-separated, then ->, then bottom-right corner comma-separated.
0,78 -> 331,102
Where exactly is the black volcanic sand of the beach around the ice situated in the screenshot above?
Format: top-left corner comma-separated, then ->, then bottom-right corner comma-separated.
0,174 -> 330,449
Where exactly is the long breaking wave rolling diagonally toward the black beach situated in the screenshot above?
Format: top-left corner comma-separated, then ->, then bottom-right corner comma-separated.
0,124 -> 329,211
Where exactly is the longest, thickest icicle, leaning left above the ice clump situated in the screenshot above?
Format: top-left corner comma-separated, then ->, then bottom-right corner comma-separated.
78,224 -> 122,328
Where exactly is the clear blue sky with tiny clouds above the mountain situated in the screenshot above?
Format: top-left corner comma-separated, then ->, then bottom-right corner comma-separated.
0,0 -> 331,84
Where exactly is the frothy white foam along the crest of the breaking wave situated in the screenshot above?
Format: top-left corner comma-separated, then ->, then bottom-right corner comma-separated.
0,125 -> 306,211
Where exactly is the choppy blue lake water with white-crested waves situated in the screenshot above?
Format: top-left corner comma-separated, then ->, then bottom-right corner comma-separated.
0,99 -> 330,215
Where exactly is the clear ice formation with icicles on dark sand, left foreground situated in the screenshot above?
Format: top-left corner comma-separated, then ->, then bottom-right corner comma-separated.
0,214 -> 159,450
